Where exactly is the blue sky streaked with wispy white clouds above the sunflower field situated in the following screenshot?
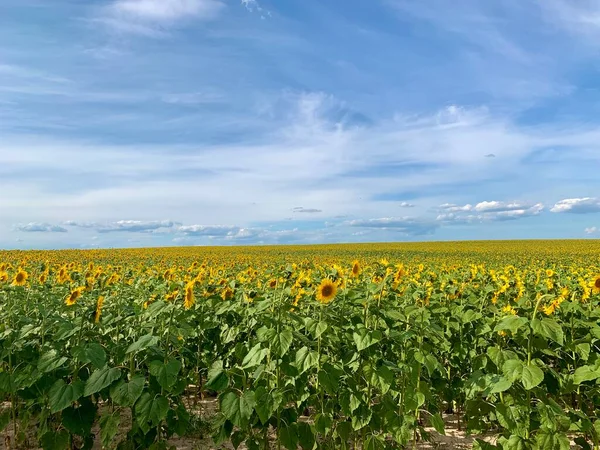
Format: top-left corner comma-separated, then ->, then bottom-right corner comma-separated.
0,0 -> 600,248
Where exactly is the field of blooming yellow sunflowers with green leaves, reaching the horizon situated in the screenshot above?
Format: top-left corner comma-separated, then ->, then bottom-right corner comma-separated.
0,241 -> 600,450
